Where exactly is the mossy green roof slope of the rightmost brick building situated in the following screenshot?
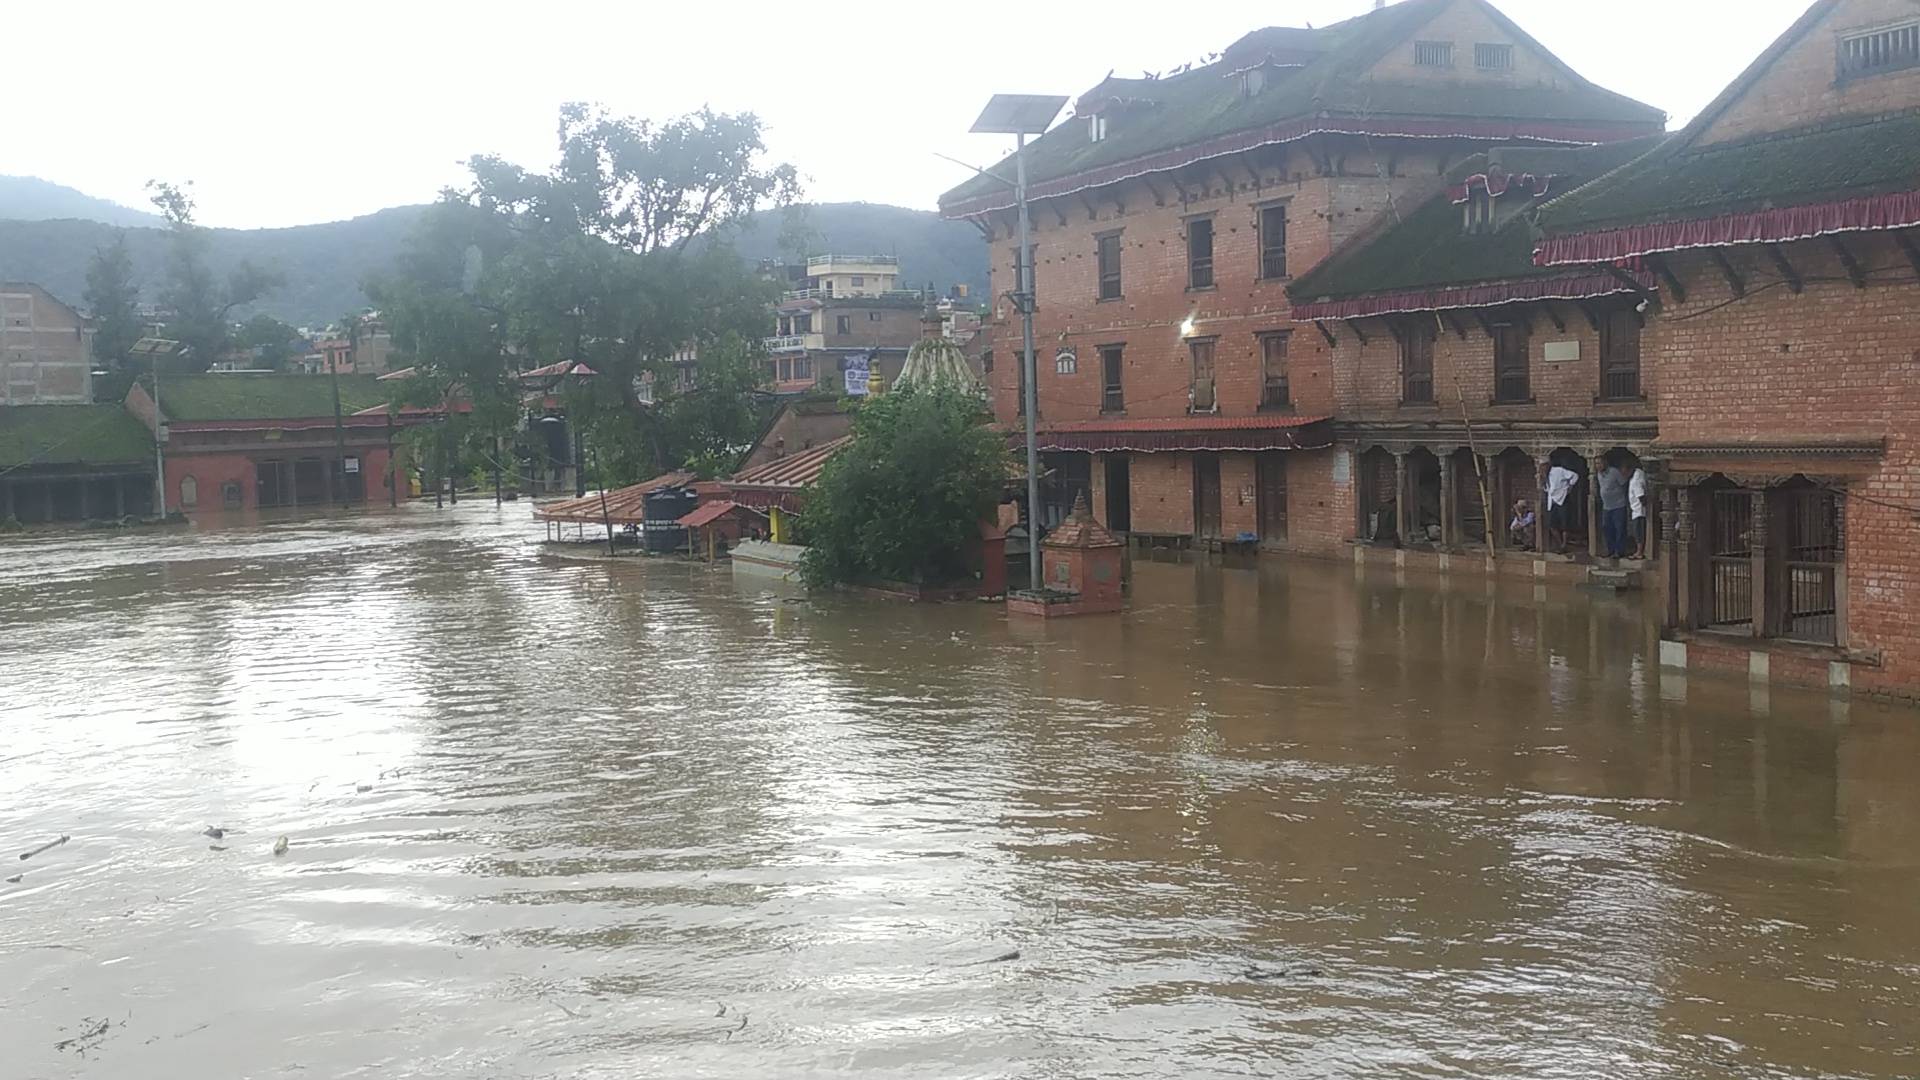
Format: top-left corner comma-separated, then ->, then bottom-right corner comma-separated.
1542,110 -> 1920,234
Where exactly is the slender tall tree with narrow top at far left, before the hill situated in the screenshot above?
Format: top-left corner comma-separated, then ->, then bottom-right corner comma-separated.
146,181 -> 284,369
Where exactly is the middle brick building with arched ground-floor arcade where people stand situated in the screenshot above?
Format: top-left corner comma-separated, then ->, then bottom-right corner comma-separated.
1288,136 -> 1659,578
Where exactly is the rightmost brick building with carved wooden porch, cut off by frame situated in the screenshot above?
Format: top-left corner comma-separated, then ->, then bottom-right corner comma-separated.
1536,0 -> 1920,696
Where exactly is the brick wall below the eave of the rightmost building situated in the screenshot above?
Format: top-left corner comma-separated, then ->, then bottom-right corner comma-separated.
1645,234 -> 1920,690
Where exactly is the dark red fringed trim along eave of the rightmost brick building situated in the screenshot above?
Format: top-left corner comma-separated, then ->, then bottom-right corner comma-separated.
1534,190 -> 1920,267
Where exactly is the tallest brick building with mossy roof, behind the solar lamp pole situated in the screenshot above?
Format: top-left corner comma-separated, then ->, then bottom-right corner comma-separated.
941,0 -> 1665,550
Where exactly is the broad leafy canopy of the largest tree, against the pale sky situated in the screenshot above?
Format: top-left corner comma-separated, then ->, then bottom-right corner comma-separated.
369,104 -> 797,479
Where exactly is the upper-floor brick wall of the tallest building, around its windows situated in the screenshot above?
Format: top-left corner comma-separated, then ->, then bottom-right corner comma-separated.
983,138 -> 1443,421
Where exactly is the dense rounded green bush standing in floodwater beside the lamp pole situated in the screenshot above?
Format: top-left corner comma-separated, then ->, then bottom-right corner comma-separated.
801,386 -> 1008,586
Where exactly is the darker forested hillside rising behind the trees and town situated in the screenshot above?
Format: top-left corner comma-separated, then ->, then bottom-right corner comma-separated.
0,202 -> 987,327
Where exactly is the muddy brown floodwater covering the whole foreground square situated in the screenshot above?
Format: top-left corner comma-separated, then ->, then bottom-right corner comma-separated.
0,505 -> 1920,1080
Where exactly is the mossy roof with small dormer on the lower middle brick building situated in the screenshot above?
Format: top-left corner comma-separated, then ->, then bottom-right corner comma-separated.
1286,138 -> 1655,304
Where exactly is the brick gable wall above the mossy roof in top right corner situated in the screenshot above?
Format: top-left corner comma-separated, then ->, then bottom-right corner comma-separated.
1701,0 -> 1920,144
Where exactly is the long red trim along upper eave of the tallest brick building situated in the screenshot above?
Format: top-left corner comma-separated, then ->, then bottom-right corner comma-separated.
941,117 -> 1647,217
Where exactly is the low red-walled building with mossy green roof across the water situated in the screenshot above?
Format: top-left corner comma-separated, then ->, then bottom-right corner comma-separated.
127,375 -> 396,515
